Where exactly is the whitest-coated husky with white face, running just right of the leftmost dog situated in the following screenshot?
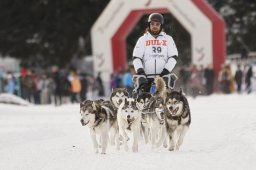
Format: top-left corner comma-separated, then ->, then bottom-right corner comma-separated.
117,98 -> 141,152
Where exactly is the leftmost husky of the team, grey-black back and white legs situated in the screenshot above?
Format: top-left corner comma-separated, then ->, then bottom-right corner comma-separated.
80,100 -> 119,154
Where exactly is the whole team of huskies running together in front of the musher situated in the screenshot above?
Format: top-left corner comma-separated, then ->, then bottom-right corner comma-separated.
80,77 -> 191,154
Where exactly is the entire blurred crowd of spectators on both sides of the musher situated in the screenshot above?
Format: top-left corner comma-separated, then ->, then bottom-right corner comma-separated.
0,57 -> 256,106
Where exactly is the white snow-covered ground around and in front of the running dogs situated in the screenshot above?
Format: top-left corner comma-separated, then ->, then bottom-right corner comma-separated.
0,94 -> 256,170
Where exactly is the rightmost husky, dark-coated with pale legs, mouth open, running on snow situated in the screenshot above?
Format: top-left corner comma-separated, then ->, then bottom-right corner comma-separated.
165,90 -> 191,151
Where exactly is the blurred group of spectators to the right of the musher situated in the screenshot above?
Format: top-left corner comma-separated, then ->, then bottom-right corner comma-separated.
179,59 -> 256,97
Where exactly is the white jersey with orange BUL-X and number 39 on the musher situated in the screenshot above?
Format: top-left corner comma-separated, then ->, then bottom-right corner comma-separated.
133,32 -> 178,75
